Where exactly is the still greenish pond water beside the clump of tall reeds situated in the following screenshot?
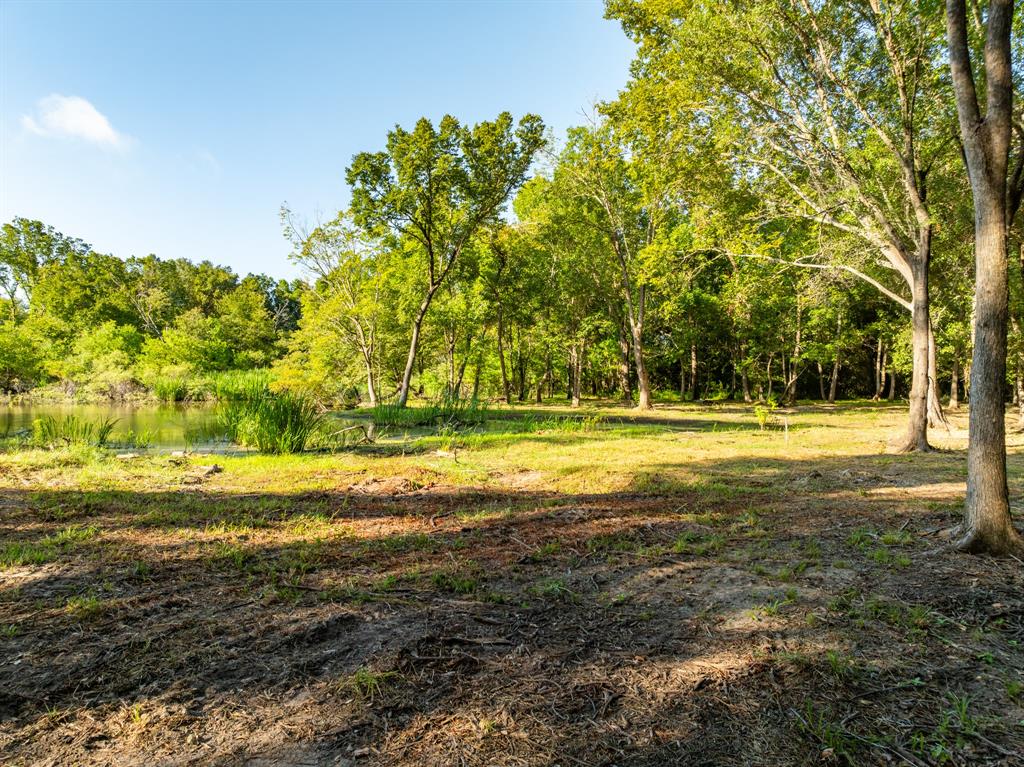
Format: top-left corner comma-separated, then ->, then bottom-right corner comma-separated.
0,402 -> 368,452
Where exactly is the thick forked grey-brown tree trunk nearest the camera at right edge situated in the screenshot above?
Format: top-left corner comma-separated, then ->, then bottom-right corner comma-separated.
946,0 -> 1024,554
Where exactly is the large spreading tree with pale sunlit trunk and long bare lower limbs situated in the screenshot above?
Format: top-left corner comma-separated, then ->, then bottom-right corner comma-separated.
608,0 -> 948,442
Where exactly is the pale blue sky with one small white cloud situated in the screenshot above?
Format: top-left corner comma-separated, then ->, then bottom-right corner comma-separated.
0,0 -> 633,276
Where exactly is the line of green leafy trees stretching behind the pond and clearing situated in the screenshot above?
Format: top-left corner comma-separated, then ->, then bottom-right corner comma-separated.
0,0 -> 1024,548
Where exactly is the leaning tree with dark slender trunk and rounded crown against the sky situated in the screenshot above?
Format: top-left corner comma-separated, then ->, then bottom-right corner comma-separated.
346,113 -> 544,407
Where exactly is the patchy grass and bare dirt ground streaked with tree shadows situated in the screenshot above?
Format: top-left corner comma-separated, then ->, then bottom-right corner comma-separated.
0,403 -> 1024,767
